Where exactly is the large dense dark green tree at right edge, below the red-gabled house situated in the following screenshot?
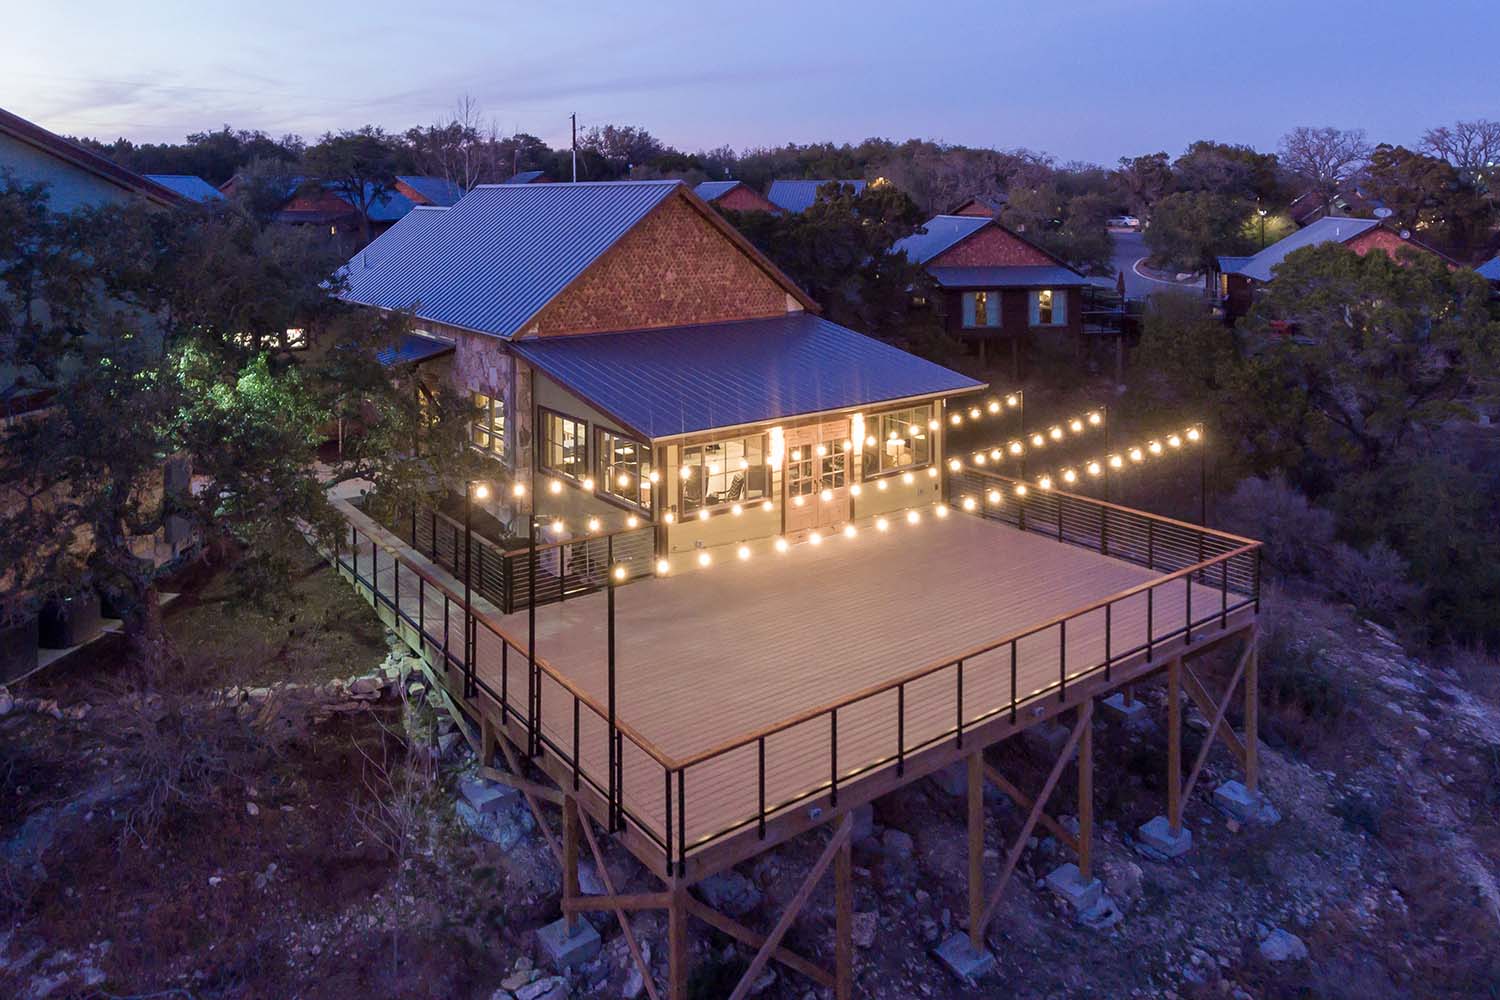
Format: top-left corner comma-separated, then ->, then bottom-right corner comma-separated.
1235,243 -> 1500,479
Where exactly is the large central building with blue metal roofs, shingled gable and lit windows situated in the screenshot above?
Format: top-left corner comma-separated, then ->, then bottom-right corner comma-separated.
345,180 -> 983,559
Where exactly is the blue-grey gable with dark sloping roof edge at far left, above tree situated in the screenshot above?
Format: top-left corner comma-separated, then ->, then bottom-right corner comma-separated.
0,109 -> 188,211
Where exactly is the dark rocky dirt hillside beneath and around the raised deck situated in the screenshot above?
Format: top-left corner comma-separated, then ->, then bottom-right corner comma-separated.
0,542 -> 1500,1000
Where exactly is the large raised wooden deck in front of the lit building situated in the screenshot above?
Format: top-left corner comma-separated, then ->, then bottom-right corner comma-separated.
343,511 -> 1242,855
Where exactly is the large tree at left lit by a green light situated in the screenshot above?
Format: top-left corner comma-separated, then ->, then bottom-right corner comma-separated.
0,184 -> 465,684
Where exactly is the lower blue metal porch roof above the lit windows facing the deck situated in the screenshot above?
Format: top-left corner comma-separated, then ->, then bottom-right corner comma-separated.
512,312 -> 984,439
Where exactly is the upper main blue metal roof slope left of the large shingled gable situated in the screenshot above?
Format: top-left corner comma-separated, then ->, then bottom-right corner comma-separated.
344,180 -> 681,344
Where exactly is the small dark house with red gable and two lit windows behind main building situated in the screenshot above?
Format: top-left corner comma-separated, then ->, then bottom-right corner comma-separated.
893,216 -> 1089,375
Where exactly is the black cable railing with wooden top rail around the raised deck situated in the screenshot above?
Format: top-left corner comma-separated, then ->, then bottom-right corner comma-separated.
336,471 -> 1260,873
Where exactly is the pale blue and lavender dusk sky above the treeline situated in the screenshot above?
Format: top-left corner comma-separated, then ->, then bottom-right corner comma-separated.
0,0 -> 1500,163
